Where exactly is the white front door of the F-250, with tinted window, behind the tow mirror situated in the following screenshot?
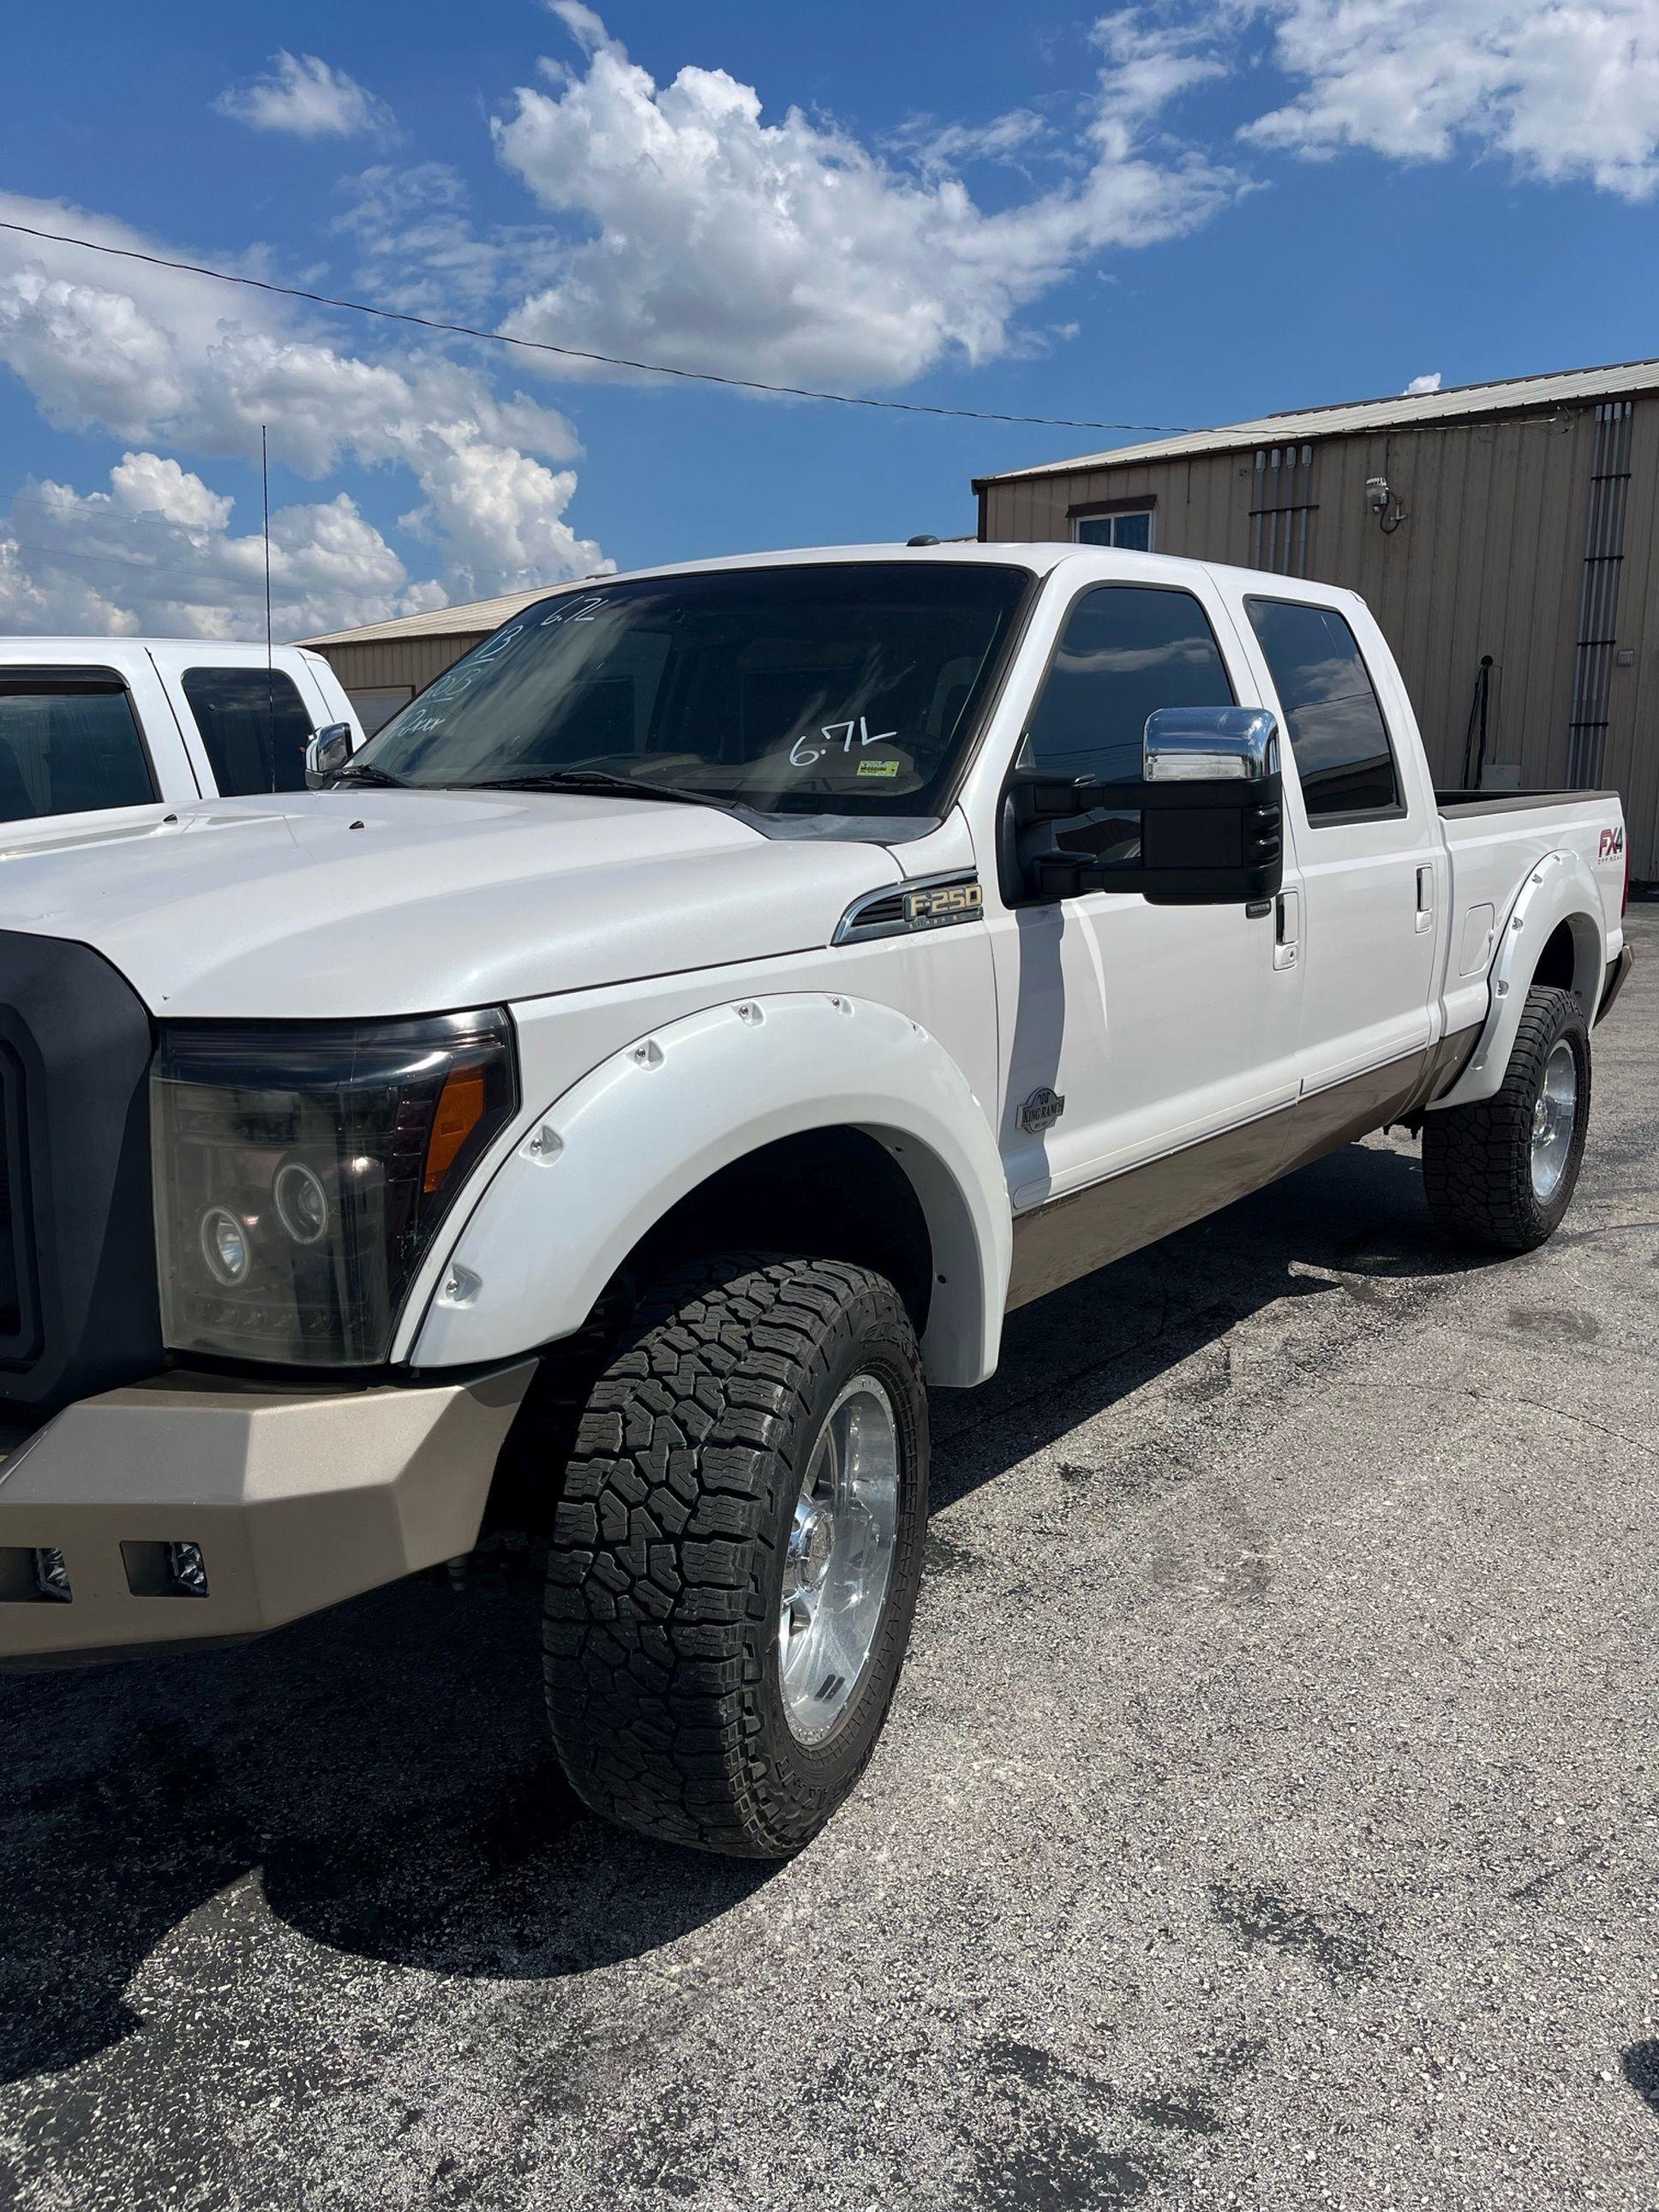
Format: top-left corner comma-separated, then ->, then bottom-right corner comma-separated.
991,579 -> 1301,1212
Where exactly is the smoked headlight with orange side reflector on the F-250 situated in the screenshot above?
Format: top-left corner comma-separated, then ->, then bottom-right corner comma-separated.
151,1007 -> 518,1367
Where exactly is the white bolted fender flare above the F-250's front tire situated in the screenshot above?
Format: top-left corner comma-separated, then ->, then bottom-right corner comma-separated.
409,991 -> 1013,1387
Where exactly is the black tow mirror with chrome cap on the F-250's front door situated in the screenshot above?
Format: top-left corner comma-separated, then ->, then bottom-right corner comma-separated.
1011,706 -> 1285,907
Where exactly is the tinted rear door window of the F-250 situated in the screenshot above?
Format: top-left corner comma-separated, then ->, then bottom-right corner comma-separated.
1248,600 -> 1400,821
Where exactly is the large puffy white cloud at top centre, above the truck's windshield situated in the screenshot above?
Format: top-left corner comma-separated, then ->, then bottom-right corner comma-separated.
495,0 -> 1234,385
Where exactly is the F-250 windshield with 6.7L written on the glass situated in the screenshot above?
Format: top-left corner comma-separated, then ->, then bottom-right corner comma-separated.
354,562 -> 1031,814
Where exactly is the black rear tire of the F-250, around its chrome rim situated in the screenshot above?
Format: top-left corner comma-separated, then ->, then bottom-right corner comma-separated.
1422,984 -> 1590,1252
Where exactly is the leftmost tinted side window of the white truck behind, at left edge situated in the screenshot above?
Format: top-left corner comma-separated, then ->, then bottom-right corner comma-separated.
0,675 -> 155,823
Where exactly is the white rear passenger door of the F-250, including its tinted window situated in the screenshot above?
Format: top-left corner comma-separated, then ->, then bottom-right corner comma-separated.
1241,577 -> 1446,1091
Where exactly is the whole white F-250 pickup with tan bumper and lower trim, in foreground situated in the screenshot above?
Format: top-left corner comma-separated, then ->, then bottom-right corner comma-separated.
0,544 -> 1628,1856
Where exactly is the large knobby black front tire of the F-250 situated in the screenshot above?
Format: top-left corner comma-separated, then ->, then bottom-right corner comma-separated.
542,1252 -> 927,1858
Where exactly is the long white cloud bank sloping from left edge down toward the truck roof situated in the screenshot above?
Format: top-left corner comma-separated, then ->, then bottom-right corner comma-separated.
0,194 -> 608,624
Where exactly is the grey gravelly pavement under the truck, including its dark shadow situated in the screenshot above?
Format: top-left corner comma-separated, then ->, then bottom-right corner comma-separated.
0,907 -> 1659,2212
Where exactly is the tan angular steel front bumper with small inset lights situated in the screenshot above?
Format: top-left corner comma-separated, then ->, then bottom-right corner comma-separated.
0,1360 -> 536,1661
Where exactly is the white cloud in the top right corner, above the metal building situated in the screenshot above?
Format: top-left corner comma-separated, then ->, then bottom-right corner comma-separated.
1243,0 -> 1659,199
